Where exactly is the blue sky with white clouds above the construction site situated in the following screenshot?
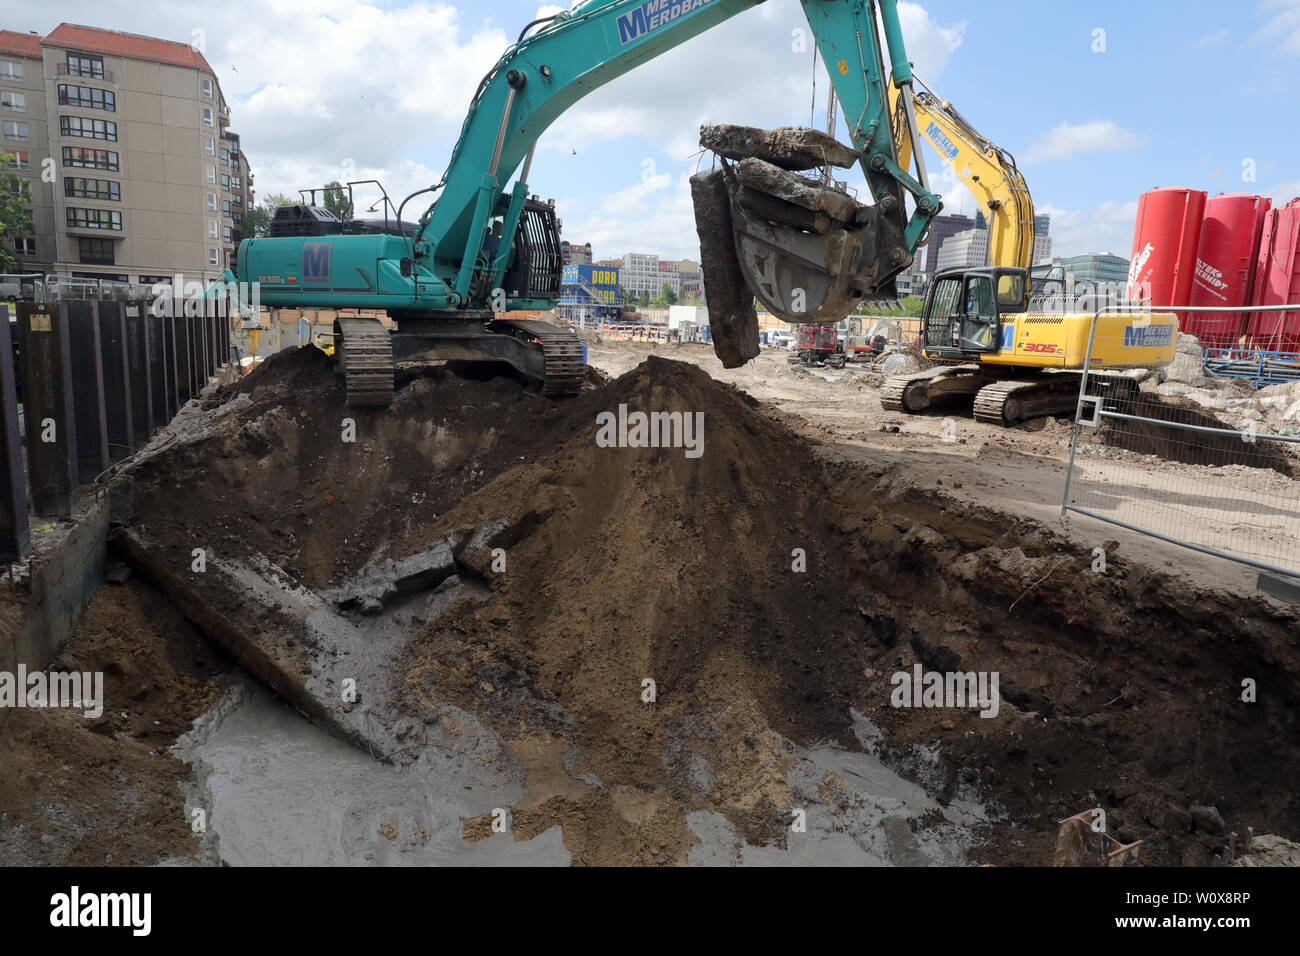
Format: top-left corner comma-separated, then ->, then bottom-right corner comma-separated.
10,0 -> 1300,259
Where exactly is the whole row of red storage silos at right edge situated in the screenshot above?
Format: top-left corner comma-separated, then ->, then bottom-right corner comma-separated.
1128,187 -> 1300,351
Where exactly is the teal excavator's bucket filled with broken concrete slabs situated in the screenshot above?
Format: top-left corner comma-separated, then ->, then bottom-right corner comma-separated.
690,126 -> 909,368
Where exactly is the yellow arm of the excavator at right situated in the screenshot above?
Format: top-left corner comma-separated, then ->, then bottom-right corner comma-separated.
889,77 -> 1034,277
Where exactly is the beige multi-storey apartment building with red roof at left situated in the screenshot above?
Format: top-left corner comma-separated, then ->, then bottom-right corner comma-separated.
0,23 -> 254,285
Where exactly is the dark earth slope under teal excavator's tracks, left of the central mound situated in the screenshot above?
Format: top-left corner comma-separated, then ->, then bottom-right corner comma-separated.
126,347 -> 595,588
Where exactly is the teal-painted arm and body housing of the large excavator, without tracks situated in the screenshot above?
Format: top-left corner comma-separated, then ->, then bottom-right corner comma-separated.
239,0 -> 940,321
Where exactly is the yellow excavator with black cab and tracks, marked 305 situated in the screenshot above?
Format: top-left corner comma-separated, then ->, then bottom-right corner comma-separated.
880,74 -> 1178,425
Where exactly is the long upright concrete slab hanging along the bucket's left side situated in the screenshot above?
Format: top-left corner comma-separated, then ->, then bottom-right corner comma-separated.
690,168 -> 758,368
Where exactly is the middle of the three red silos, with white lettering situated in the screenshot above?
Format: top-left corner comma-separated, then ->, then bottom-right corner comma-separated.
1182,193 -> 1273,349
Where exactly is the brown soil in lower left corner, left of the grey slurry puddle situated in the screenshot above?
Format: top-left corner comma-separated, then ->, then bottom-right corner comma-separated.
0,579 -> 234,866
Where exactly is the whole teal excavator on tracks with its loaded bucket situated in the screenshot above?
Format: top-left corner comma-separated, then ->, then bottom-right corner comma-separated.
228,0 -> 941,406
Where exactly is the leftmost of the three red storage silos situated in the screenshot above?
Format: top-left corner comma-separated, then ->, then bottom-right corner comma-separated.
1128,186 -> 1205,323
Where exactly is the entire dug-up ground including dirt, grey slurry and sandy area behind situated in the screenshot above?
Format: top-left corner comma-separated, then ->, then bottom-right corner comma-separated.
0,338 -> 1300,866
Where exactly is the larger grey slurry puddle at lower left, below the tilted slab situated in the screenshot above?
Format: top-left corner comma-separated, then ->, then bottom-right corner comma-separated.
176,687 -> 569,866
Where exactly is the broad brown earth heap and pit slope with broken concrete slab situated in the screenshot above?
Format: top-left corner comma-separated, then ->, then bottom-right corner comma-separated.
98,347 -> 1300,865
